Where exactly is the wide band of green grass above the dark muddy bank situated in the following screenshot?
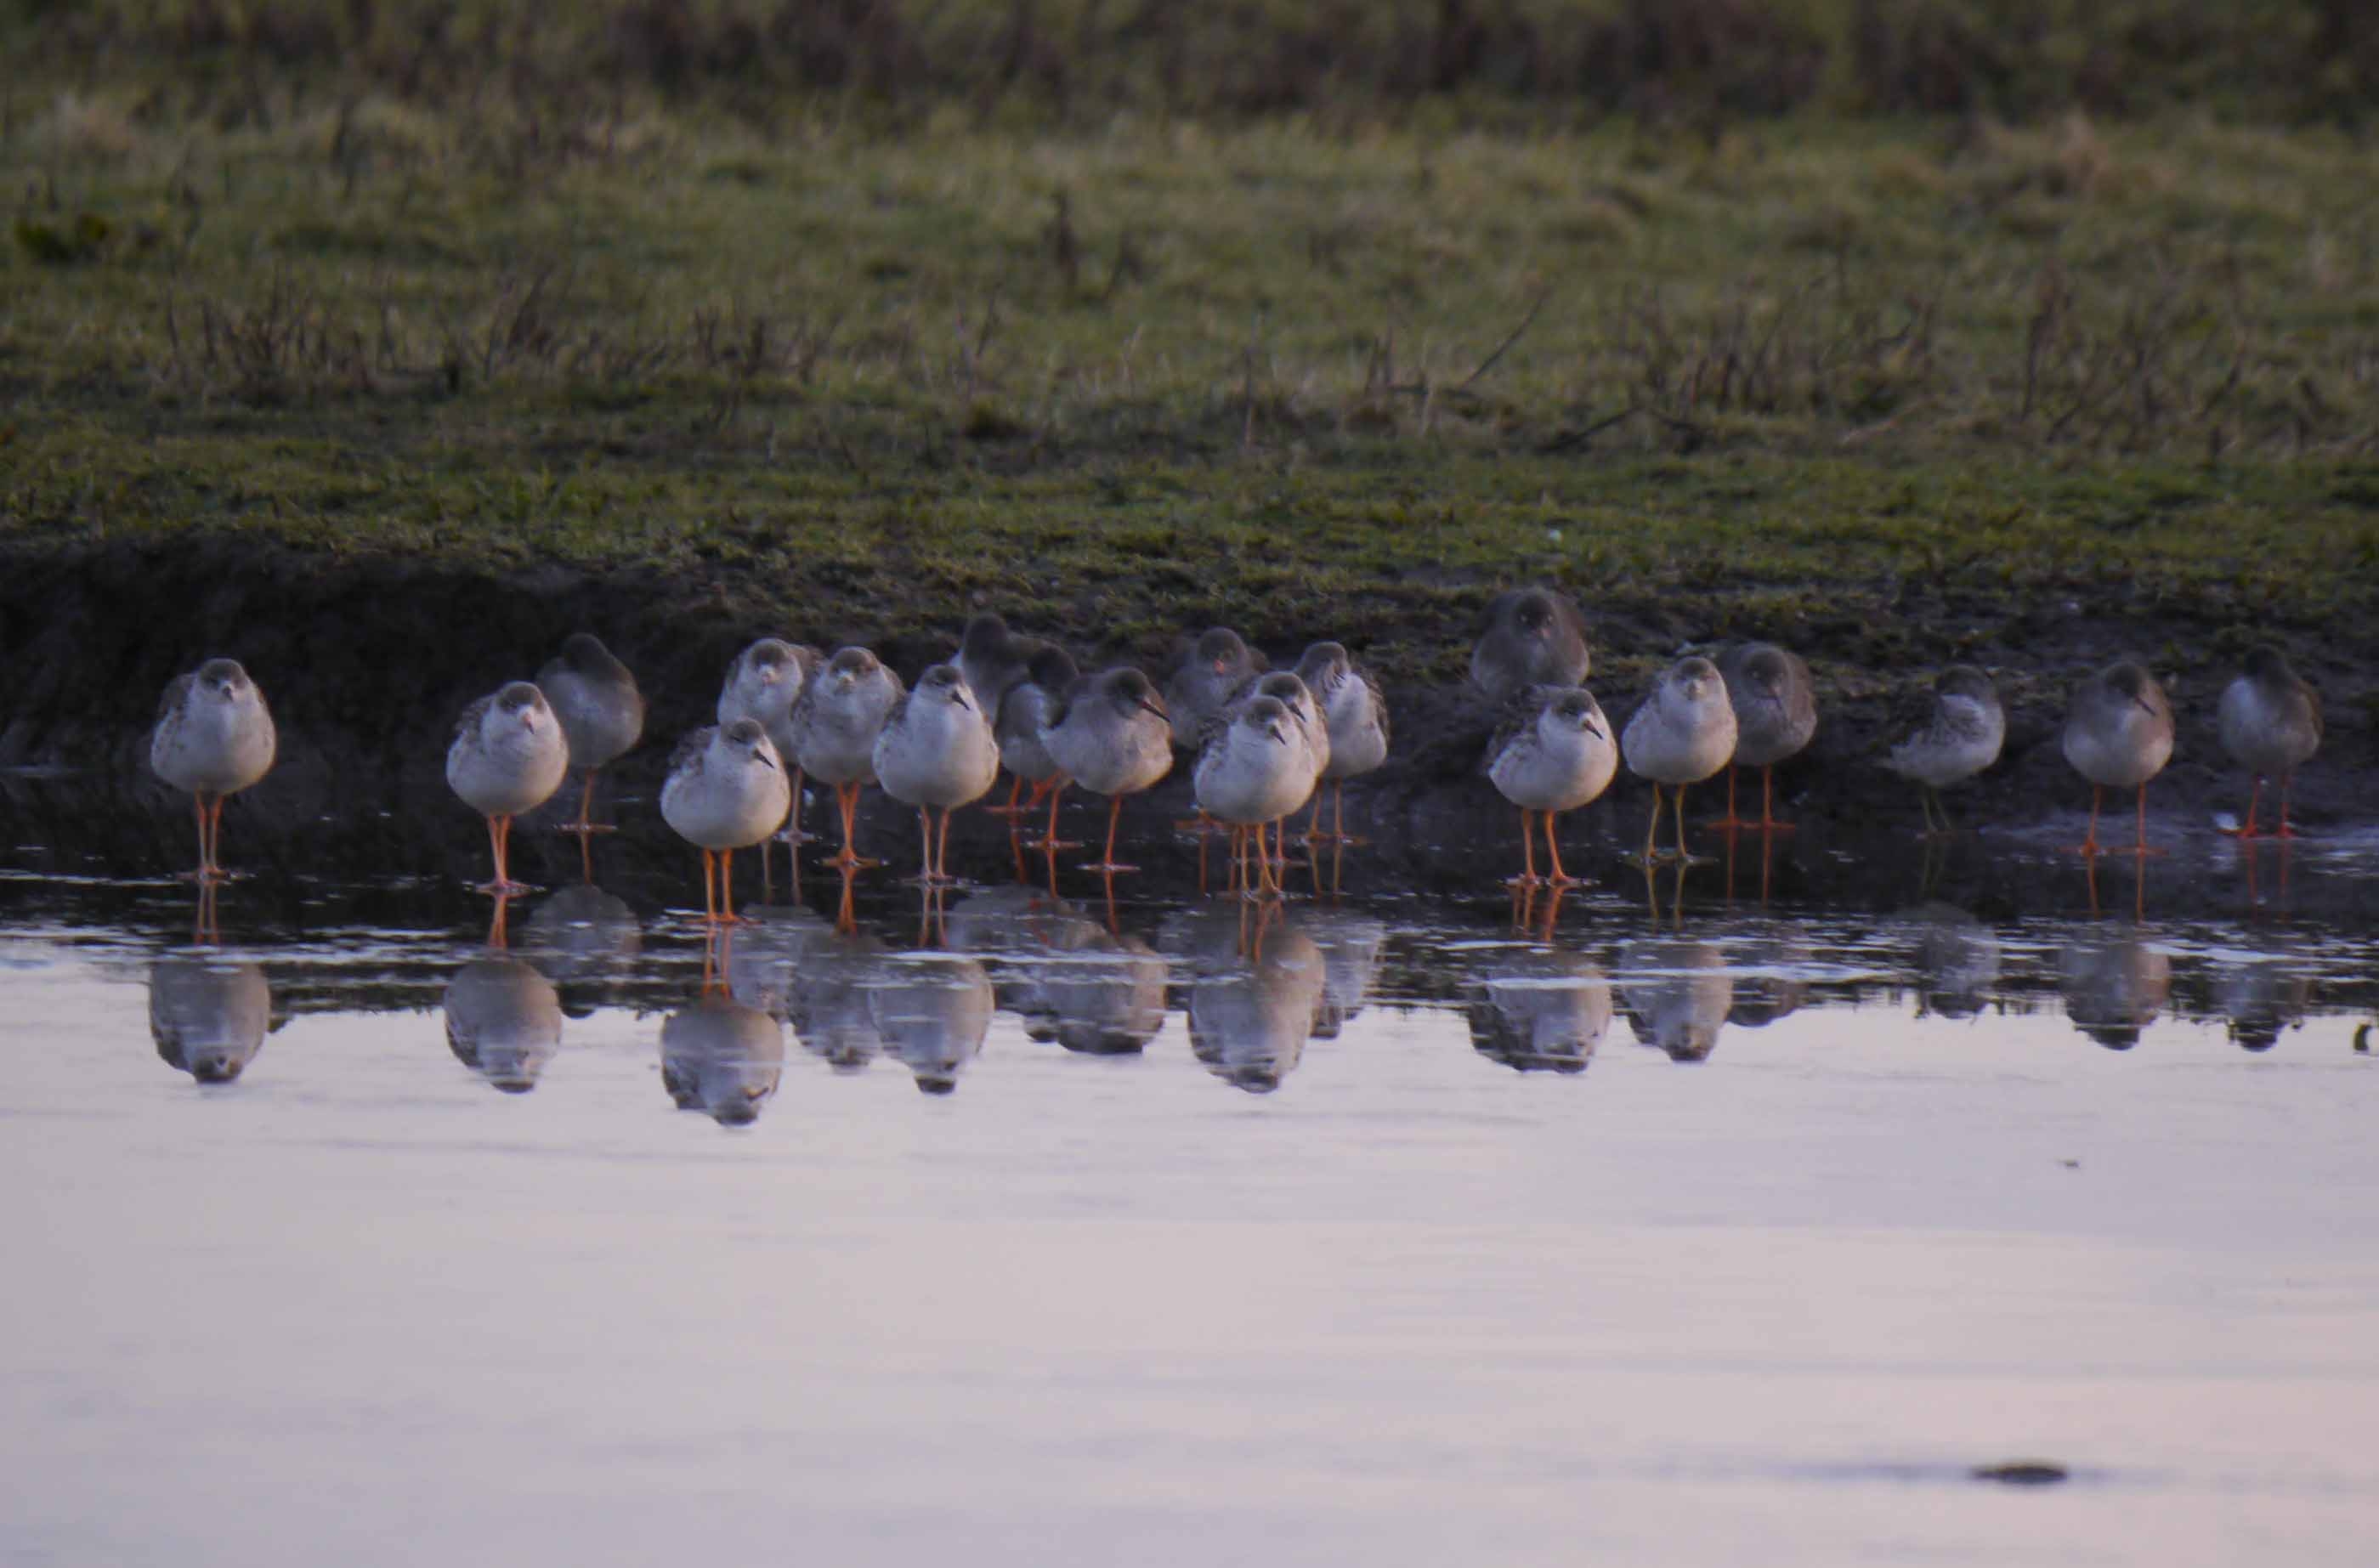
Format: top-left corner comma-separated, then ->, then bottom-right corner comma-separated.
0,90 -> 2379,676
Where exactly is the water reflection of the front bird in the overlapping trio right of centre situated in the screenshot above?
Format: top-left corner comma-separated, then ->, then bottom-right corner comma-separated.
1187,902 -> 1330,1095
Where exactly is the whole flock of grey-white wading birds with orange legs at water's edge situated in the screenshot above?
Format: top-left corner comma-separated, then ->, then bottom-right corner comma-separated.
150,588 -> 2322,923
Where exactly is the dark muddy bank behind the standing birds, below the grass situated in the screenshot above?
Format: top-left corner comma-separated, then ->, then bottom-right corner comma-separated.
0,541 -> 2379,856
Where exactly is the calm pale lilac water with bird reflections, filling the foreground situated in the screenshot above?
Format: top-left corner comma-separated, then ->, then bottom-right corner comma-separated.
0,842 -> 2379,1563
